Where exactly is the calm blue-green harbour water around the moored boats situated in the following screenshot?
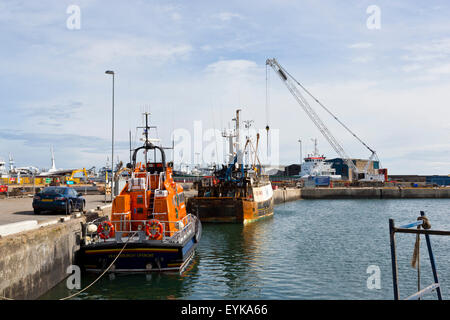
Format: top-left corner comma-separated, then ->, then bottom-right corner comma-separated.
42,199 -> 450,299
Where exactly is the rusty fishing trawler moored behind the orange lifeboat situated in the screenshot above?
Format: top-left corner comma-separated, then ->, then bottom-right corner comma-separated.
188,110 -> 273,224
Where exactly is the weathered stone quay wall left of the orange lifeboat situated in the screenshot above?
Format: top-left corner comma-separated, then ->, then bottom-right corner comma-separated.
0,218 -> 84,299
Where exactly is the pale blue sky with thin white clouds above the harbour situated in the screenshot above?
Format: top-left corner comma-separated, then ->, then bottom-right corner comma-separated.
0,0 -> 450,175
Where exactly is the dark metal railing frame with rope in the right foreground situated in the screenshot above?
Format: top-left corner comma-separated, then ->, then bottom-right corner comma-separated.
389,211 -> 450,300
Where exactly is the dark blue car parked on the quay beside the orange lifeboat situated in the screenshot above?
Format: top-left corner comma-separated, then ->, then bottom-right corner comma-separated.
33,187 -> 86,214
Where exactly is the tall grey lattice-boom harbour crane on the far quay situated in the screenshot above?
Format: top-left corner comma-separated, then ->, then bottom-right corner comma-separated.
266,58 -> 382,180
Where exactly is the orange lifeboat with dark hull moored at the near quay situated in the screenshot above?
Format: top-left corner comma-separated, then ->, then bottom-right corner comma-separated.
80,113 -> 202,272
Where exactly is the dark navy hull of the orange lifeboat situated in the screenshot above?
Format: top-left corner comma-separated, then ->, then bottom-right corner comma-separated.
78,233 -> 200,273
